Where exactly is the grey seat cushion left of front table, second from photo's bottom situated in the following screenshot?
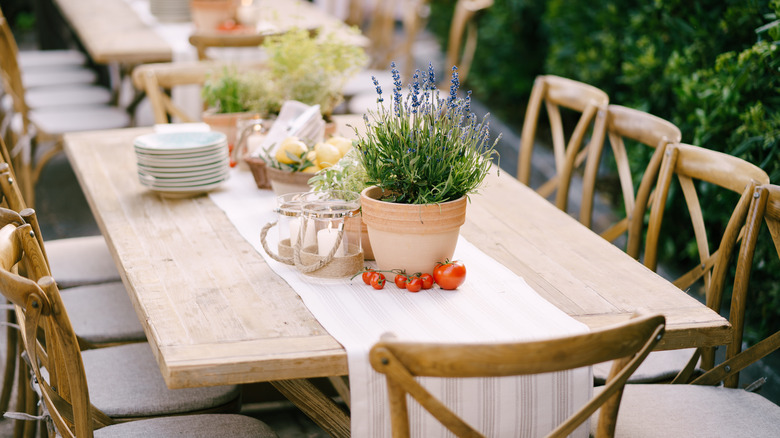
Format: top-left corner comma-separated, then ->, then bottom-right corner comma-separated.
82,342 -> 240,418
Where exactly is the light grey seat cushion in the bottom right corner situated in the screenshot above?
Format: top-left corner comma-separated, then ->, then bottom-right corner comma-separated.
591,384 -> 780,438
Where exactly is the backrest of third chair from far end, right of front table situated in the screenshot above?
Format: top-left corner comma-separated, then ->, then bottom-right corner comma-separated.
644,143 -> 769,369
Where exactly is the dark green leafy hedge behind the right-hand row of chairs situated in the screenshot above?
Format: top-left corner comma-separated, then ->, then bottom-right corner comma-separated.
429,0 -> 780,342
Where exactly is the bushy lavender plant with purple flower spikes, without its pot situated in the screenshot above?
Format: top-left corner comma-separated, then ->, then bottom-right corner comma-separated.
355,64 -> 501,204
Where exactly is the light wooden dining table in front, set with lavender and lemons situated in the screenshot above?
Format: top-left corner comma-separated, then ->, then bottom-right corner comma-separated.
64,117 -> 732,435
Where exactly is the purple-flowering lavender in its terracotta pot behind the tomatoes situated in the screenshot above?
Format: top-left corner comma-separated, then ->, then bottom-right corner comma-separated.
355,65 -> 500,273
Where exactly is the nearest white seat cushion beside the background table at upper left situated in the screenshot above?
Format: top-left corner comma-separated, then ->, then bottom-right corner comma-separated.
30,105 -> 130,135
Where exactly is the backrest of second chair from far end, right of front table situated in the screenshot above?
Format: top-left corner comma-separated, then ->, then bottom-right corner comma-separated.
580,104 -> 682,258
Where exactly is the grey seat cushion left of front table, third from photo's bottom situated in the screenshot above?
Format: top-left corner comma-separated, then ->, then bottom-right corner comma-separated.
62,281 -> 146,344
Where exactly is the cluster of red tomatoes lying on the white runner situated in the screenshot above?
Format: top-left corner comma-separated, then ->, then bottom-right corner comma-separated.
362,260 -> 466,292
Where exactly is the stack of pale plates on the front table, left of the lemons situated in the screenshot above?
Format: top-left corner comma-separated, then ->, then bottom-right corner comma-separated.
133,131 -> 230,197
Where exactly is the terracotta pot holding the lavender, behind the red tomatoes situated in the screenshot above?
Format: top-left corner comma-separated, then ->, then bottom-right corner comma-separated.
360,186 -> 466,274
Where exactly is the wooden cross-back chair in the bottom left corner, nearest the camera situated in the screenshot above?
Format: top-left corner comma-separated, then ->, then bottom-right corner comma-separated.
0,219 -> 275,438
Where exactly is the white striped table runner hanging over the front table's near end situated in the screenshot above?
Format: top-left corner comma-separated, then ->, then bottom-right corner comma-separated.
210,169 -> 592,438
